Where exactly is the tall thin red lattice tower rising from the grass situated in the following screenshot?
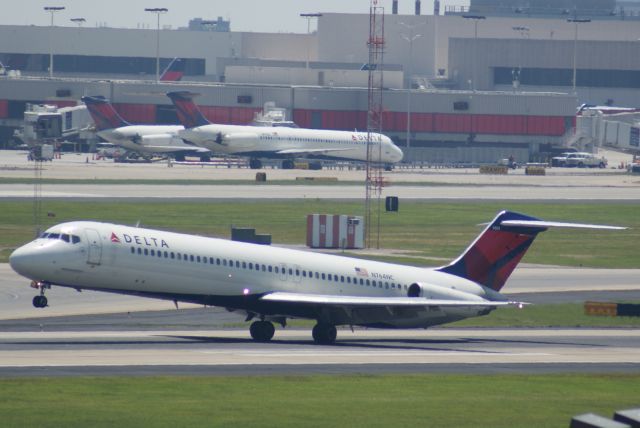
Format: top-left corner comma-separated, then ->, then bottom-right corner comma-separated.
364,0 -> 384,248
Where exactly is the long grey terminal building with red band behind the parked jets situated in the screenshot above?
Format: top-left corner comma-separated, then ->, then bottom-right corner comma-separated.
0,0 -> 640,163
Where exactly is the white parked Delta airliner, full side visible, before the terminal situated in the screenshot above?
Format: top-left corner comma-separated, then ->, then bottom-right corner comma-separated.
167,91 -> 403,169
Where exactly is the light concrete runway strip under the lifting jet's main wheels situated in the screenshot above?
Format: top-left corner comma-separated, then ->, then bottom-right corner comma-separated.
0,329 -> 640,376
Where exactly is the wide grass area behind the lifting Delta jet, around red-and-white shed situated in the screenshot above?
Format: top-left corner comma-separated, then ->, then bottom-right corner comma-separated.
0,200 -> 640,268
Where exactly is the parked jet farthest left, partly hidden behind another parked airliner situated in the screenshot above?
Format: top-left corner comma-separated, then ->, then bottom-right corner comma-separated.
81,96 -> 211,162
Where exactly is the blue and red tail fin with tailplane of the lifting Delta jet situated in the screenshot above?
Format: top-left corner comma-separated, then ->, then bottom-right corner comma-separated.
438,211 -> 625,291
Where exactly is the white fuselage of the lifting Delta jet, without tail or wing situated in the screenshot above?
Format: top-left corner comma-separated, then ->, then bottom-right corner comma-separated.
10,222 -> 500,328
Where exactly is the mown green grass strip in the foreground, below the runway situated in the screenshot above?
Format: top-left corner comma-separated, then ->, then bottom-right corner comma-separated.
0,374 -> 640,428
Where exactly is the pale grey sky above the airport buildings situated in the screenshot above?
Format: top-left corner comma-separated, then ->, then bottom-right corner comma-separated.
0,0 -> 468,33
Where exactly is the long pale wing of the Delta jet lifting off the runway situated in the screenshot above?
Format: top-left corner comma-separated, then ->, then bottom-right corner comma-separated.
260,292 -> 524,308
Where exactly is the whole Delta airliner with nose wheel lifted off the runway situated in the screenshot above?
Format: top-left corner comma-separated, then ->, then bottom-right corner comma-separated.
9,211 -> 622,344
